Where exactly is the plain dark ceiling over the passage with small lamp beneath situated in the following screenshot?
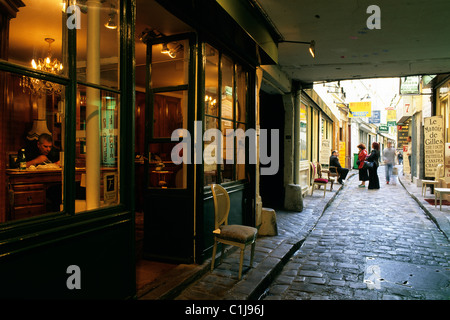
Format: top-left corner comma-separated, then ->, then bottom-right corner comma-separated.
253,0 -> 450,83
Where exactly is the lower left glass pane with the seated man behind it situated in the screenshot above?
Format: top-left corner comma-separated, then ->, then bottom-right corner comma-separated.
0,72 -> 65,222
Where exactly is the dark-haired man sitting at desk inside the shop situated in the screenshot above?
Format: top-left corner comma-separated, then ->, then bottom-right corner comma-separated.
25,133 -> 59,168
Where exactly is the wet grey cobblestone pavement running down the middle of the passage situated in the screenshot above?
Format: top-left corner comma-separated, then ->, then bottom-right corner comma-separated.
264,167 -> 450,300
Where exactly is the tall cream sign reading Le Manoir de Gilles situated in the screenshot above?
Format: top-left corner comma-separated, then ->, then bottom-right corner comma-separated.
424,116 -> 444,177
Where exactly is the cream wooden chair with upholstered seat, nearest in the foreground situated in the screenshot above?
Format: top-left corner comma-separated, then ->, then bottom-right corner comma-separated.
211,184 -> 258,280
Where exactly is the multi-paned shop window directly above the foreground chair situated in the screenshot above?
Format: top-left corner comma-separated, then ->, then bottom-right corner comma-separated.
204,44 -> 248,186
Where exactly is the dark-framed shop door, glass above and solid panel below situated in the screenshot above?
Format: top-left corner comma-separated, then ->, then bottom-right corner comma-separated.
143,34 -> 196,263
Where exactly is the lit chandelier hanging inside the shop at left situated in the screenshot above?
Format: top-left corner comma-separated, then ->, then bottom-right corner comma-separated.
20,38 -> 63,95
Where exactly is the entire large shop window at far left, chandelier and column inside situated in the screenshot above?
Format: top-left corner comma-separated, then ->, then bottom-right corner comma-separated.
0,0 -> 120,222
